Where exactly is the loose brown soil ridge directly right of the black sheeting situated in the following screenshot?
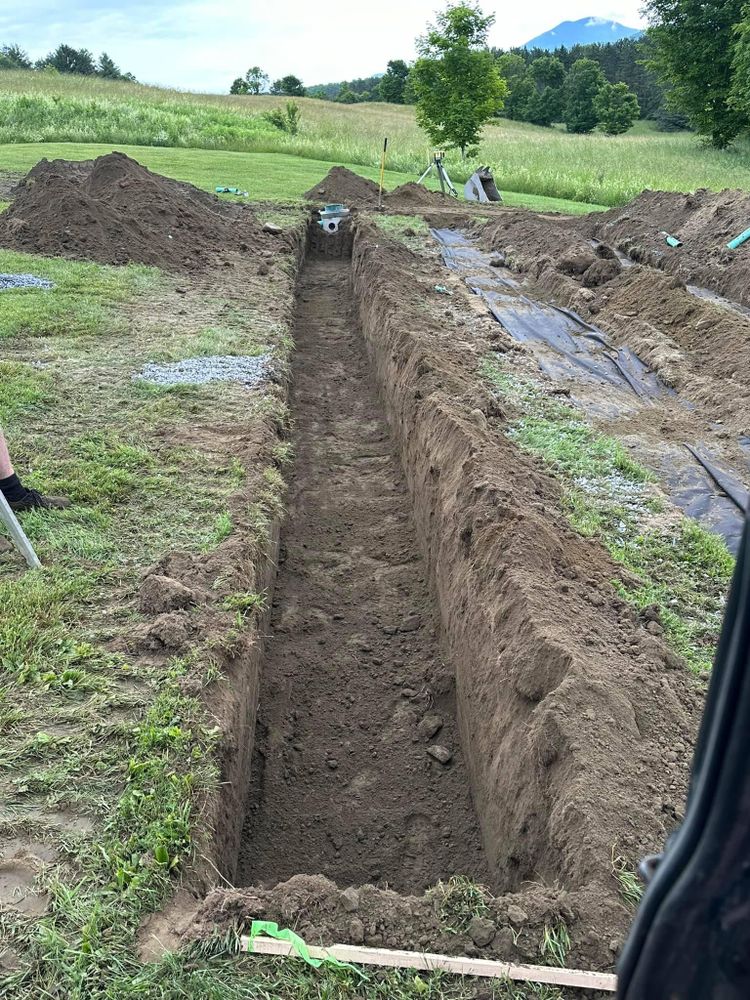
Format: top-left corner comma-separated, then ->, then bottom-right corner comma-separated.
475,206 -> 750,436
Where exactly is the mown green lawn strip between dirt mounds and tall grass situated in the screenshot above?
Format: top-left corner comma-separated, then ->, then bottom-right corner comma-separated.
0,142 -> 605,213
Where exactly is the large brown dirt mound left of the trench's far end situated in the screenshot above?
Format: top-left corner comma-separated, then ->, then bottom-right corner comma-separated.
0,153 -> 265,270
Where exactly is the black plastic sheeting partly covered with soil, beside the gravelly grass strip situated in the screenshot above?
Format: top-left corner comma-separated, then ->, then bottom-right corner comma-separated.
432,229 -> 750,552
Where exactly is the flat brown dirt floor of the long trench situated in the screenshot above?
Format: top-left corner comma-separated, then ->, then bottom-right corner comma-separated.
237,257 -> 490,892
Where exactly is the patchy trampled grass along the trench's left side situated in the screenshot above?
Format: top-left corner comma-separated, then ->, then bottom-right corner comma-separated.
0,240 -> 302,1000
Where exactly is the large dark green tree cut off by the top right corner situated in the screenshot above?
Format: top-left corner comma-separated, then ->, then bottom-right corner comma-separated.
646,0 -> 750,149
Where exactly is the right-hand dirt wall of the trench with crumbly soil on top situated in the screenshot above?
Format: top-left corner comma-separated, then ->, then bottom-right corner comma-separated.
352,226 -> 694,910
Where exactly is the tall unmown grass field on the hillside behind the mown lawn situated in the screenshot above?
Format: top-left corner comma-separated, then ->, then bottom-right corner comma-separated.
0,71 -> 750,205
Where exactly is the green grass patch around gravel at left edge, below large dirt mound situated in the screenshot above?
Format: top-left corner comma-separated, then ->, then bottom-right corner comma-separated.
0,250 -> 158,339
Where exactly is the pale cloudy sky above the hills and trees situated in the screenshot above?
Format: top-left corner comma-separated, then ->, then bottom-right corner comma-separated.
0,0 -> 643,93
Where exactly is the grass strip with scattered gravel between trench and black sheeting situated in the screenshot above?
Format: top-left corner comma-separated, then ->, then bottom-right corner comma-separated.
482,356 -> 734,673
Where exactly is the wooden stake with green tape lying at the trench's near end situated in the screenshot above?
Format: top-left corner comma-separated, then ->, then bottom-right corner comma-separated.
240,936 -> 617,993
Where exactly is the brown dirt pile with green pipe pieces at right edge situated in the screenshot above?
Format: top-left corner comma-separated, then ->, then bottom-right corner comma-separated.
577,188 -> 750,305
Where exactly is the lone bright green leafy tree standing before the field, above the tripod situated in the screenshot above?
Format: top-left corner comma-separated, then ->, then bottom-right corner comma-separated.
410,3 -> 508,157
